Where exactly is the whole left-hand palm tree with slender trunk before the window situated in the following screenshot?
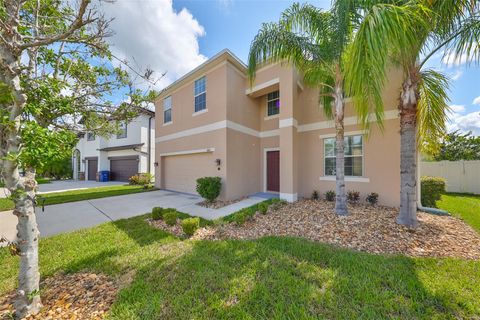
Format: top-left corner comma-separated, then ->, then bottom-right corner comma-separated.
248,3 -> 364,215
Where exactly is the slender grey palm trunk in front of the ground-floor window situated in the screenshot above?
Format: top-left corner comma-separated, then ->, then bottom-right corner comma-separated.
334,75 -> 348,215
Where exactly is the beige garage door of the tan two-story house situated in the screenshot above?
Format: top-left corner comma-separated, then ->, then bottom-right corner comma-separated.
163,152 -> 218,194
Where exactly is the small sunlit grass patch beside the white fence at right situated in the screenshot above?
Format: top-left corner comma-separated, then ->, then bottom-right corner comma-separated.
437,193 -> 480,233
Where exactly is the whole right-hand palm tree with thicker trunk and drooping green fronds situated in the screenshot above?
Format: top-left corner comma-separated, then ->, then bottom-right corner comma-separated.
344,0 -> 480,227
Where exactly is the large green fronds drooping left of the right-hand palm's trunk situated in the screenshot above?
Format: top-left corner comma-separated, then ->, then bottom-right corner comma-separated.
345,3 -> 428,127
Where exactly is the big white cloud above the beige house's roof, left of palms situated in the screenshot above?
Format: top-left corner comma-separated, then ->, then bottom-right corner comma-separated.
103,0 -> 206,89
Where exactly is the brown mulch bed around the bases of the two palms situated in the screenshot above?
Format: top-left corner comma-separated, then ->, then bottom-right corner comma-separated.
193,200 -> 480,259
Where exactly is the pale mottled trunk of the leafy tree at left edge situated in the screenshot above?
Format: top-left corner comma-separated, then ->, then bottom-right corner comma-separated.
0,50 -> 42,319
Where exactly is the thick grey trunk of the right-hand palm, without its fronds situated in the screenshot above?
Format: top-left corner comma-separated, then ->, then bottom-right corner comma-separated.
397,69 -> 419,227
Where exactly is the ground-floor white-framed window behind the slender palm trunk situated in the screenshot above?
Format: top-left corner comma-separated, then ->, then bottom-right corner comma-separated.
324,135 -> 363,177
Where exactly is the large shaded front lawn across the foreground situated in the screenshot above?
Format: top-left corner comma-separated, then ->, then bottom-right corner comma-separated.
0,210 -> 480,320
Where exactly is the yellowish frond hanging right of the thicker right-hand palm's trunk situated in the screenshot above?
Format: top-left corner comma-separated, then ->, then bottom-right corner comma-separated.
417,70 -> 450,154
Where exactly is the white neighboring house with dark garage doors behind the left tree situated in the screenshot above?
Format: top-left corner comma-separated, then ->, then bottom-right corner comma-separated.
73,109 -> 155,181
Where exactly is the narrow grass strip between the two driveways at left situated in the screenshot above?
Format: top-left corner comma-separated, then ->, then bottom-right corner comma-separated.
0,185 -> 155,211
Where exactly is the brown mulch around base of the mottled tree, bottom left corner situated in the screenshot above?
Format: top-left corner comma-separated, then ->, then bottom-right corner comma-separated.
0,273 -> 118,320
